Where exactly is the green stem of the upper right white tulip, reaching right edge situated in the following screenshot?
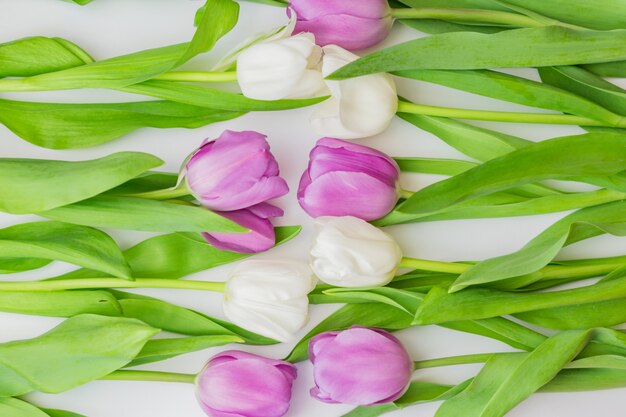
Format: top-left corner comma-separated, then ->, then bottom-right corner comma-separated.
398,100 -> 626,128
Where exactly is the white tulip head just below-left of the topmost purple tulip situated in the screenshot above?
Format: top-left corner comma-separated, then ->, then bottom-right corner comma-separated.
237,33 -> 328,100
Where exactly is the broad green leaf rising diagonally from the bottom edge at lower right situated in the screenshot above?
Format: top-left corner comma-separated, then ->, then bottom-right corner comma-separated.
435,331 -> 589,417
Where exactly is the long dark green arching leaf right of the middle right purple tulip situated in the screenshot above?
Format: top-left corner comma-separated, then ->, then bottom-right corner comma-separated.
397,133 -> 626,214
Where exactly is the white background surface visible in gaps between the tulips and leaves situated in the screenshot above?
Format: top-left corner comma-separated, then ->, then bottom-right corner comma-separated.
0,0 -> 626,417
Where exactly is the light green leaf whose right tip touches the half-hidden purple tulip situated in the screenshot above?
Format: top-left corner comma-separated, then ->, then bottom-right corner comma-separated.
38,195 -> 247,233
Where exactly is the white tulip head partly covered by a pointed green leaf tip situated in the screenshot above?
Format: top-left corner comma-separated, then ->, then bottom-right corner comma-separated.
311,45 -> 398,139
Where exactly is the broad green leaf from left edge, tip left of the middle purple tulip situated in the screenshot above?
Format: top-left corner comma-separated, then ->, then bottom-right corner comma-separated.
0,152 -> 163,214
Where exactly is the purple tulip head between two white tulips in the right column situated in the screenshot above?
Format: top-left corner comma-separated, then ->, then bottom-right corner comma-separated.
298,138 -> 399,221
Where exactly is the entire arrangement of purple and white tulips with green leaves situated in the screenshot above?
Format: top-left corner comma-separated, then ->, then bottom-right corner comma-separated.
0,0 -> 626,417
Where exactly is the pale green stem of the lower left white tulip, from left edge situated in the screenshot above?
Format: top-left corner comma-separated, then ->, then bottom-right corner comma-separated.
0,278 -> 225,292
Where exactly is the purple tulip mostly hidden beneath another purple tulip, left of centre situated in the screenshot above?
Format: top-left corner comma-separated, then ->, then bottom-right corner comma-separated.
202,203 -> 284,253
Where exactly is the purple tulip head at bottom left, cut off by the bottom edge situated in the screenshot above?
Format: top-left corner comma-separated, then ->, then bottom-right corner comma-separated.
196,350 -> 297,417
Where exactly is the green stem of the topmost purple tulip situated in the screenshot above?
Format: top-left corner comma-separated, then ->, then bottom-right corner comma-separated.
391,7 -> 545,28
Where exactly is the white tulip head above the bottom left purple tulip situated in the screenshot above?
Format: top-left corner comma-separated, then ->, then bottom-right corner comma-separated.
223,260 -> 317,342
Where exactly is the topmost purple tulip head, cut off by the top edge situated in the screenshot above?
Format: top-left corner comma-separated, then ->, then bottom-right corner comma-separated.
287,0 -> 393,51
